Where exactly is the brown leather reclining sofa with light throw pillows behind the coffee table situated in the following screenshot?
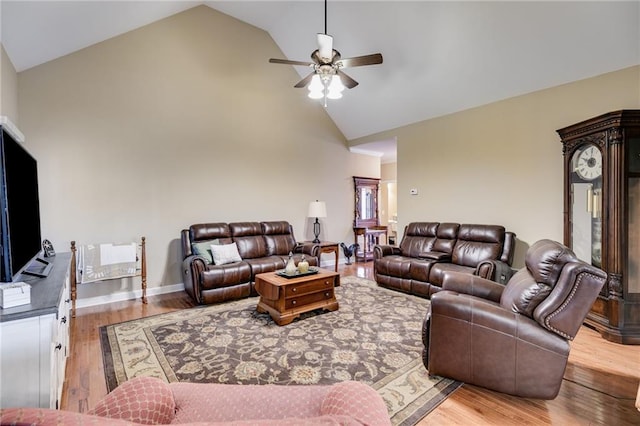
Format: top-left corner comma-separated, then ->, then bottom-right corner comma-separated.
181,221 -> 319,304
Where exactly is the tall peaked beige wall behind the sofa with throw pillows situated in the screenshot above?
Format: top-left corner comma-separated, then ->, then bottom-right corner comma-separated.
19,6 -> 380,297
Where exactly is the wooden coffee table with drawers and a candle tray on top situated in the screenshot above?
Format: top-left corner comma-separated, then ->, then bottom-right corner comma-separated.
255,268 -> 340,325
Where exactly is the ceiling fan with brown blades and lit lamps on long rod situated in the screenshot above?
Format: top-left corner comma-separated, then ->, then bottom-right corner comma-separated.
269,0 -> 382,107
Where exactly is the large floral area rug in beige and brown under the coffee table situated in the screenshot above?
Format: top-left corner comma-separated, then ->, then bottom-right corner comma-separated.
100,277 -> 461,425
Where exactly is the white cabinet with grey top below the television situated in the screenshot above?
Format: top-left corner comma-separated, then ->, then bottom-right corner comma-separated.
0,253 -> 71,408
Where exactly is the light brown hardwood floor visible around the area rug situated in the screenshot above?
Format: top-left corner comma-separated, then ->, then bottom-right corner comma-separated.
61,262 -> 640,425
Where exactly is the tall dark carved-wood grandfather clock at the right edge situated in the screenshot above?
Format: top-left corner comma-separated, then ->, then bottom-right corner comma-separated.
557,110 -> 640,344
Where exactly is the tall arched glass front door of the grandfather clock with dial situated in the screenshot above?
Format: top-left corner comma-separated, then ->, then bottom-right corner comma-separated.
570,144 -> 602,267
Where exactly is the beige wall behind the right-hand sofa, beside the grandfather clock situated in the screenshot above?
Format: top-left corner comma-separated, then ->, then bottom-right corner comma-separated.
350,66 -> 640,266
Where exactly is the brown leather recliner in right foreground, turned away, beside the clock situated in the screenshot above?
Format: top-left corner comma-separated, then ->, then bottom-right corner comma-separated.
422,240 -> 607,399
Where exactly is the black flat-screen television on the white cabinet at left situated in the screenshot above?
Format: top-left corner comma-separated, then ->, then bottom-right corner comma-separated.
0,124 -> 51,282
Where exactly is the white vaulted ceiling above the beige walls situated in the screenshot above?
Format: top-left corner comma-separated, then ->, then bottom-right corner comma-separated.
0,0 -> 640,156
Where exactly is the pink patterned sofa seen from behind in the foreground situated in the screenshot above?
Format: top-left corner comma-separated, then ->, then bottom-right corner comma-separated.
0,377 -> 391,426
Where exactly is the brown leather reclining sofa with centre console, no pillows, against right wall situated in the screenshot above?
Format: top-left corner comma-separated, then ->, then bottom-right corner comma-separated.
373,222 -> 516,297
